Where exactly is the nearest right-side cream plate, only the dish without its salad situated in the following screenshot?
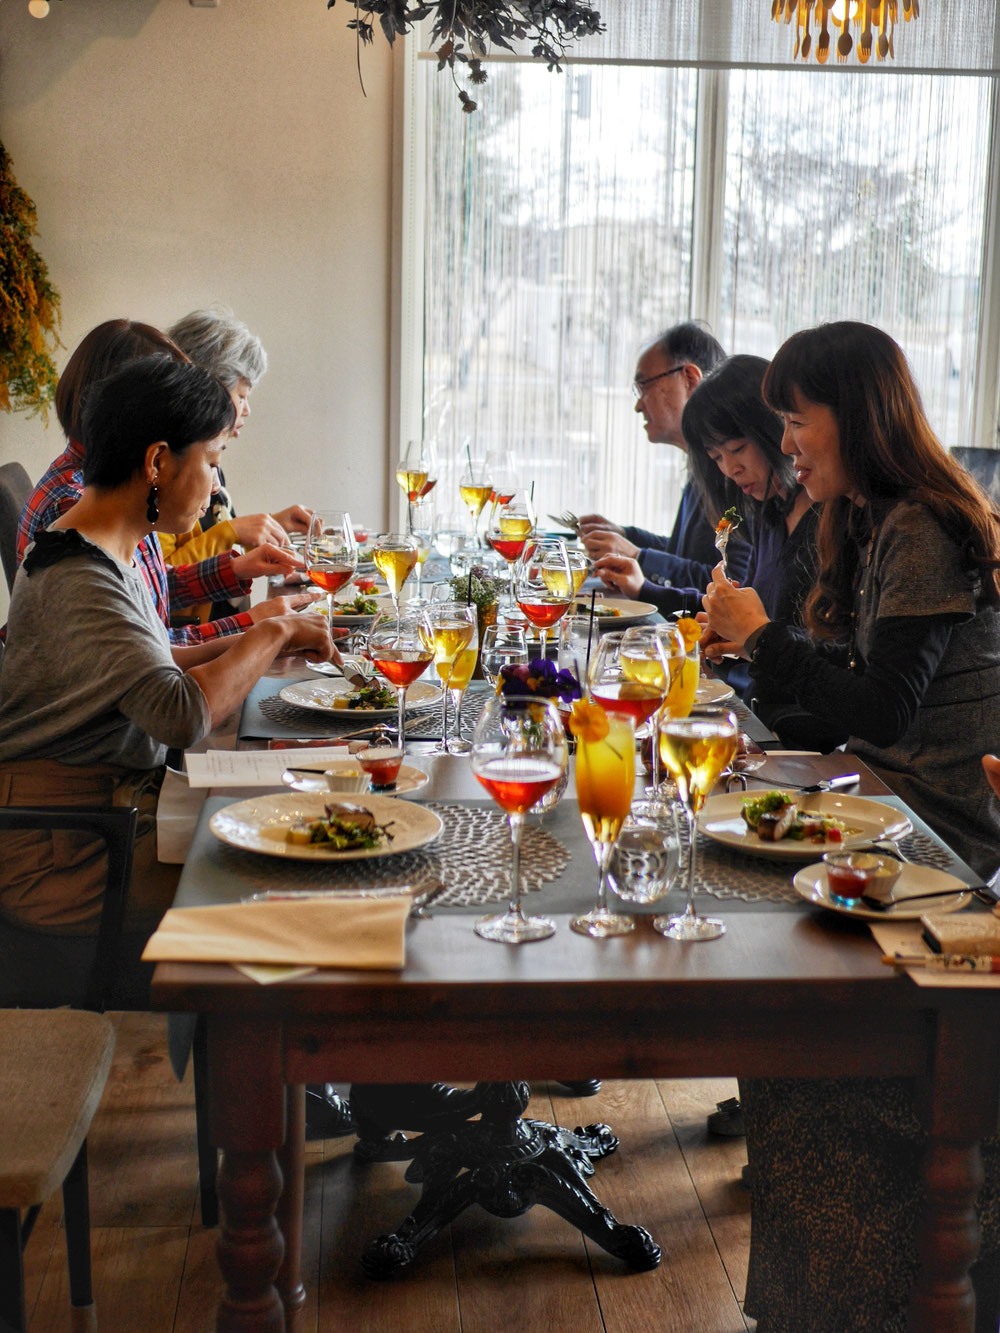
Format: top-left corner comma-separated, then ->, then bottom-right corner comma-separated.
697,786 -> 912,861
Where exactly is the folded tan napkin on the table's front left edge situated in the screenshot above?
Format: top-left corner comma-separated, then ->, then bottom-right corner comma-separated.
143,894 -> 412,968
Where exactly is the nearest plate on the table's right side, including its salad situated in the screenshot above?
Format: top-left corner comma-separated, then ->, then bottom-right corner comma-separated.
697,789 -> 912,861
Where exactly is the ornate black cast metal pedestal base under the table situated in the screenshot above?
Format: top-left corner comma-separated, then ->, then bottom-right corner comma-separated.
351,1082 -> 660,1278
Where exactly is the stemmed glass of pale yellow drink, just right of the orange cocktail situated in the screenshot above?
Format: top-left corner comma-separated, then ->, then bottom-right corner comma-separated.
653,704 -> 739,940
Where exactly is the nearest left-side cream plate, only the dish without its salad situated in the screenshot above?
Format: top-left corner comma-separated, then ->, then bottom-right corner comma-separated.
208,792 -> 441,861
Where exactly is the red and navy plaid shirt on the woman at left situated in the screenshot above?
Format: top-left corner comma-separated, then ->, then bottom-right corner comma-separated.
17,440 -> 253,645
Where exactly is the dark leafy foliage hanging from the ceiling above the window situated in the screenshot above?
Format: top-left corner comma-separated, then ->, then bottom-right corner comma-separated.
333,0 -> 604,111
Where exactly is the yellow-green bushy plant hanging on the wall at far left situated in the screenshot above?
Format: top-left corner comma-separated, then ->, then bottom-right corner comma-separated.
0,144 -> 61,421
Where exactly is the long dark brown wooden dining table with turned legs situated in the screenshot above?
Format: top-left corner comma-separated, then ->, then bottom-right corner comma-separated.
153,682 -> 1000,1333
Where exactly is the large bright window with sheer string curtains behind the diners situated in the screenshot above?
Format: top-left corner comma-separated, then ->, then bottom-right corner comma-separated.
403,20 -> 1000,531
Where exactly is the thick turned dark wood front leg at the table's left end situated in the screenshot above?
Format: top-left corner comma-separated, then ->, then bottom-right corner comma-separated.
208,1016 -> 285,1333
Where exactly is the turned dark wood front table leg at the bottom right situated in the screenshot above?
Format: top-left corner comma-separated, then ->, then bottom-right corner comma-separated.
909,1013 -> 1000,1333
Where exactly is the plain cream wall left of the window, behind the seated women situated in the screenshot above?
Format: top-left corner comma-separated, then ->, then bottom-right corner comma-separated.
0,0 -> 392,619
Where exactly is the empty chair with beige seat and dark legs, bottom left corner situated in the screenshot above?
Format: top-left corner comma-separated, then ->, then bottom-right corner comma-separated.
0,1009 -> 115,1333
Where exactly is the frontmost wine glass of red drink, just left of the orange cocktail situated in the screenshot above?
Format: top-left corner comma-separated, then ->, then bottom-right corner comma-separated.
472,694 -> 565,944
